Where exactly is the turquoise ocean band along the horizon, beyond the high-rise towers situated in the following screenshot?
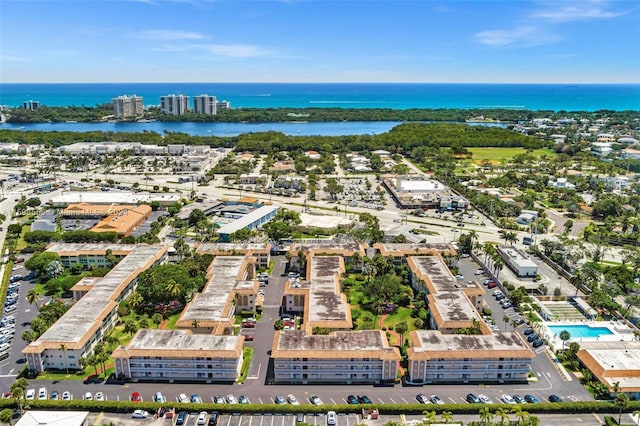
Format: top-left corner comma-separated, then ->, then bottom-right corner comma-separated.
0,83 -> 640,111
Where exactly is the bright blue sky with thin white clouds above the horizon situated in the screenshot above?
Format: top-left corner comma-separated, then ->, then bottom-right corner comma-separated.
0,0 -> 640,83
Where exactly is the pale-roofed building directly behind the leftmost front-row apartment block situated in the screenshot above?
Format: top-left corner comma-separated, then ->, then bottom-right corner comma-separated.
176,256 -> 259,335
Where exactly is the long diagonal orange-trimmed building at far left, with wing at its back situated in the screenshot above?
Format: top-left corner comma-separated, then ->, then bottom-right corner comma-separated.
22,244 -> 167,373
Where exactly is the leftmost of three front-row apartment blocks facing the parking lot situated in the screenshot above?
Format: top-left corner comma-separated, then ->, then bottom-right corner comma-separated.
112,329 -> 244,382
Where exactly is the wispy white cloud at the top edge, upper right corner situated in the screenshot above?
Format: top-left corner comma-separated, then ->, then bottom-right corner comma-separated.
531,0 -> 627,22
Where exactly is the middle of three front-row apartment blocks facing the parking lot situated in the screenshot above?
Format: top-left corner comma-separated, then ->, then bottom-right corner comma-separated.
271,330 -> 400,384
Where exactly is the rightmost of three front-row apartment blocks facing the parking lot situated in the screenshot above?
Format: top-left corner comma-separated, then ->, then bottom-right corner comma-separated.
407,330 -> 535,384
